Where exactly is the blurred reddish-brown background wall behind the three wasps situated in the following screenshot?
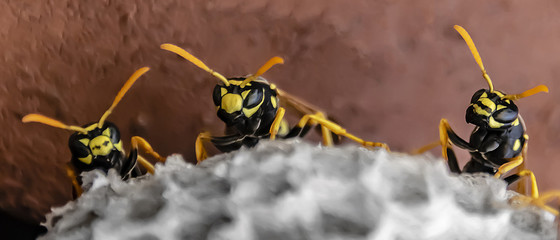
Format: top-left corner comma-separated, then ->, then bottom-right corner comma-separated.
0,0 -> 560,236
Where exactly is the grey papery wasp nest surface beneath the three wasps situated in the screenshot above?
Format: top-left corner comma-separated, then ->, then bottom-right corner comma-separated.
41,141 -> 557,240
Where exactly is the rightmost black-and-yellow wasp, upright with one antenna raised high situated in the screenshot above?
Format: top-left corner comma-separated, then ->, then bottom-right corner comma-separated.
417,25 -> 560,215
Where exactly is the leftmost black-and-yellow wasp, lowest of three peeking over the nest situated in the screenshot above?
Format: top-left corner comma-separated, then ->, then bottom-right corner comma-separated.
22,67 -> 165,196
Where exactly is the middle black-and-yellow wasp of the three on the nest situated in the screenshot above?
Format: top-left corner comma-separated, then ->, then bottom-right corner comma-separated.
161,44 -> 389,162
